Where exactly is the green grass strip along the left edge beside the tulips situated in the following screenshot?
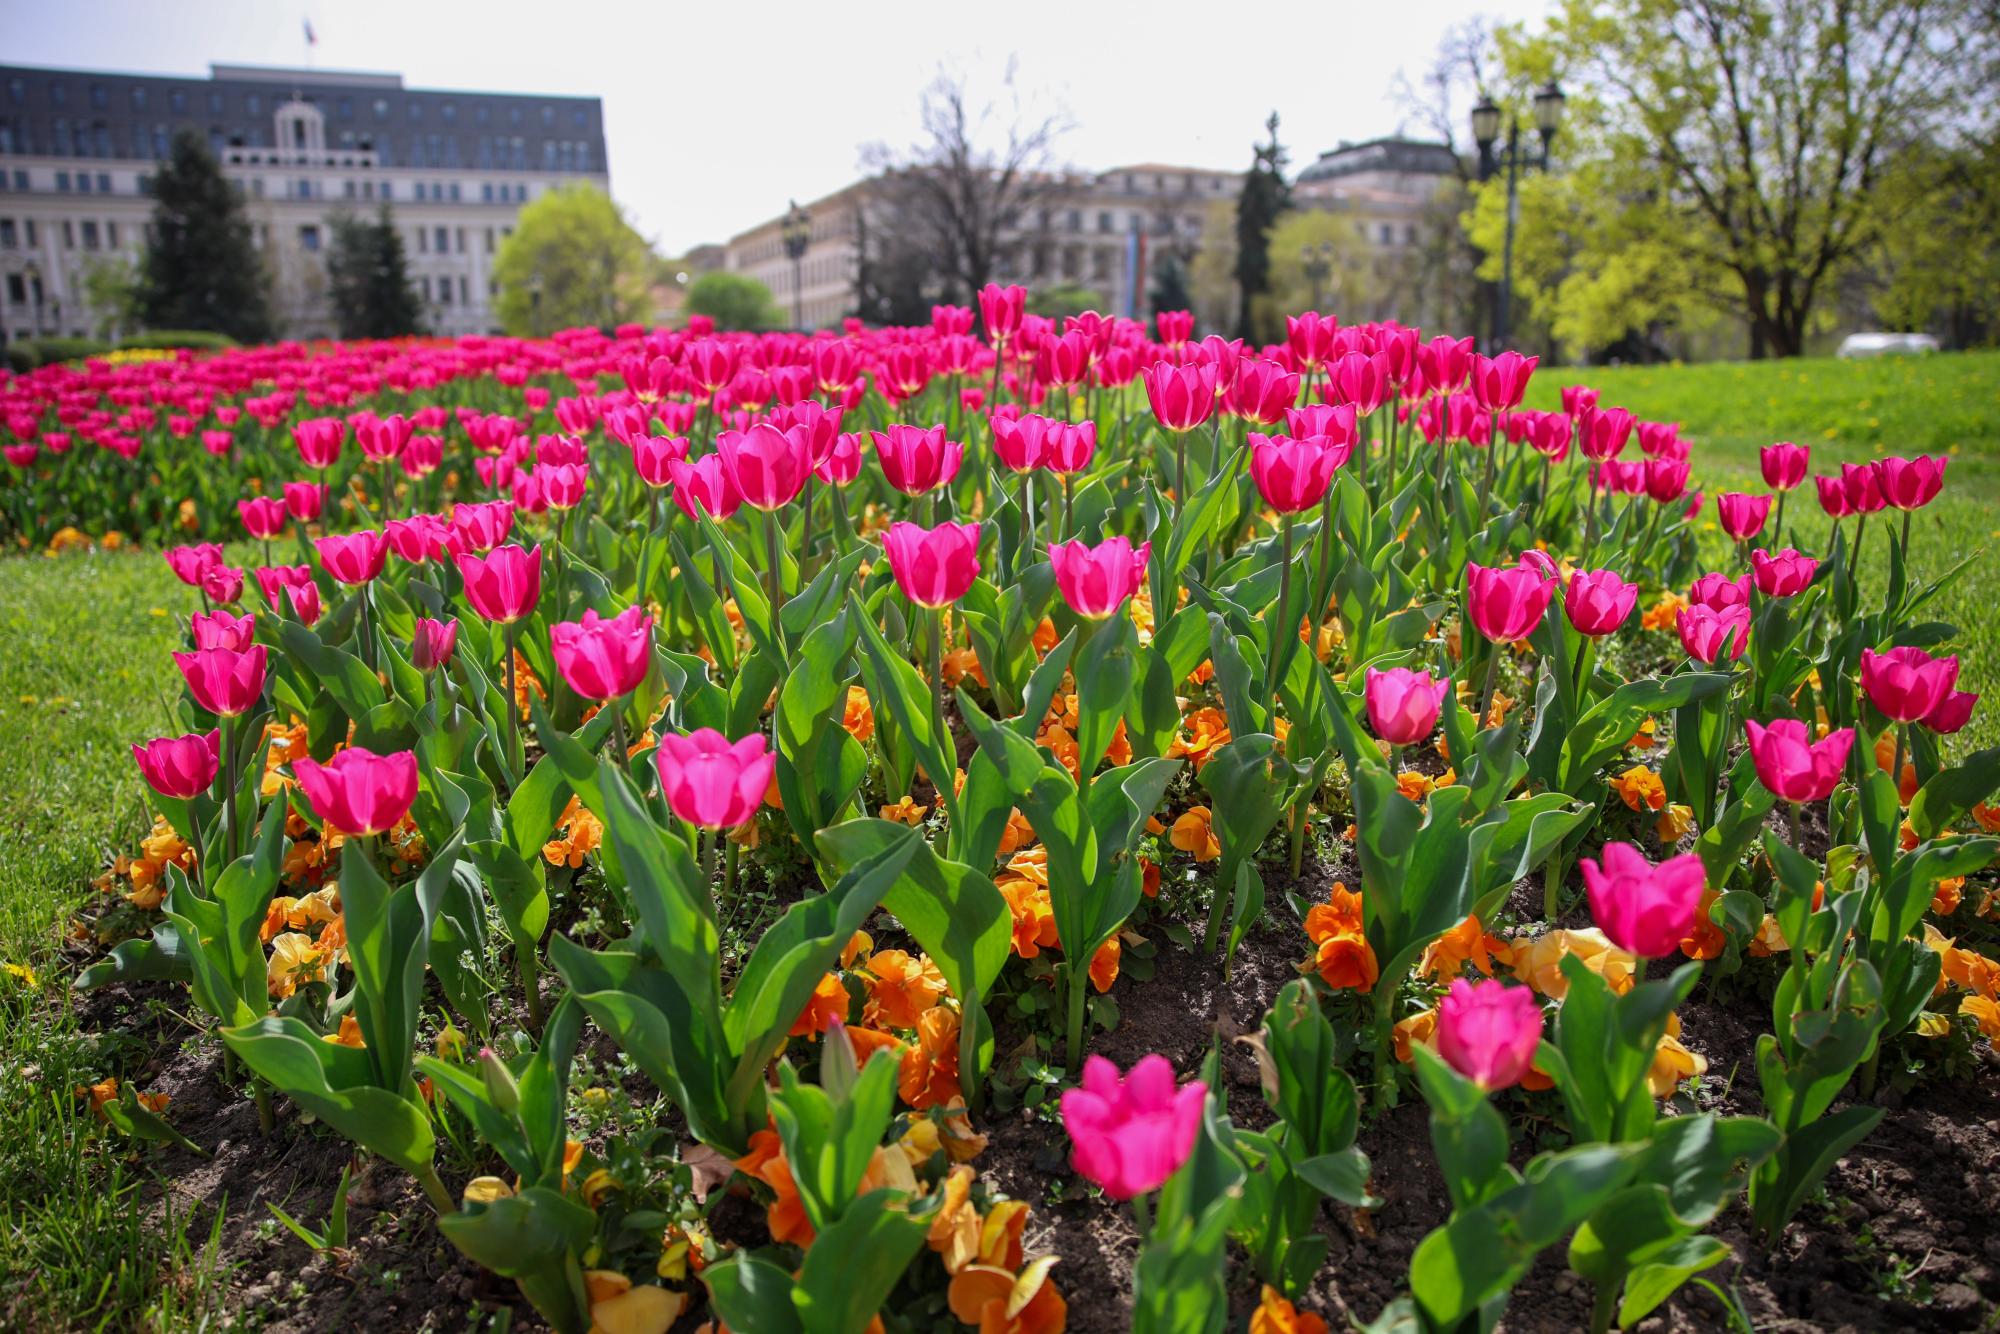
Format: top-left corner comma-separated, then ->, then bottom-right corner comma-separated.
0,554 -> 232,1330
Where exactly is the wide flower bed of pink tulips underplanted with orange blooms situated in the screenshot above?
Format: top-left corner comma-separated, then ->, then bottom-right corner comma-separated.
0,302 -> 2000,1330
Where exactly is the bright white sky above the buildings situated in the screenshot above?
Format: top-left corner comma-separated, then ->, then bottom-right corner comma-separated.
0,0 -> 1548,254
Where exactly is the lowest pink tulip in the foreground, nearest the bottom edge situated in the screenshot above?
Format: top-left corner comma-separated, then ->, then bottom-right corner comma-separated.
1062,1054 -> 1208,1200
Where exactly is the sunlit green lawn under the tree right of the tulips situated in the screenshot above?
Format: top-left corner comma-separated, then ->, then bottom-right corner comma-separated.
1528,352 -> 2000,748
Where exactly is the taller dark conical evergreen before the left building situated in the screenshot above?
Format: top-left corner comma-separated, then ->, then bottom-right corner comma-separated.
140,130 -> 274,342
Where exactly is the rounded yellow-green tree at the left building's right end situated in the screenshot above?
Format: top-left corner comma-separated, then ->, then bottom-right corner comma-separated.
494,182 -> 652,336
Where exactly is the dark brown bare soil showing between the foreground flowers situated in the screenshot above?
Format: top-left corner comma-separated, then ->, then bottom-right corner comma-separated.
54,844 -> 2000,1334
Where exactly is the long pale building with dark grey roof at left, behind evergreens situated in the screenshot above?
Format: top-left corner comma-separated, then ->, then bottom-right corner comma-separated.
0,66 -> 610,340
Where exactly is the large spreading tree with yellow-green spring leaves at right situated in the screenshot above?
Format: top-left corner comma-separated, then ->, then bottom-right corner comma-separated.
1504,0 -> 1992,356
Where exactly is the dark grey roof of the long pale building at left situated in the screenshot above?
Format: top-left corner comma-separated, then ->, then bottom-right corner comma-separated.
0,64 -> 606,172
